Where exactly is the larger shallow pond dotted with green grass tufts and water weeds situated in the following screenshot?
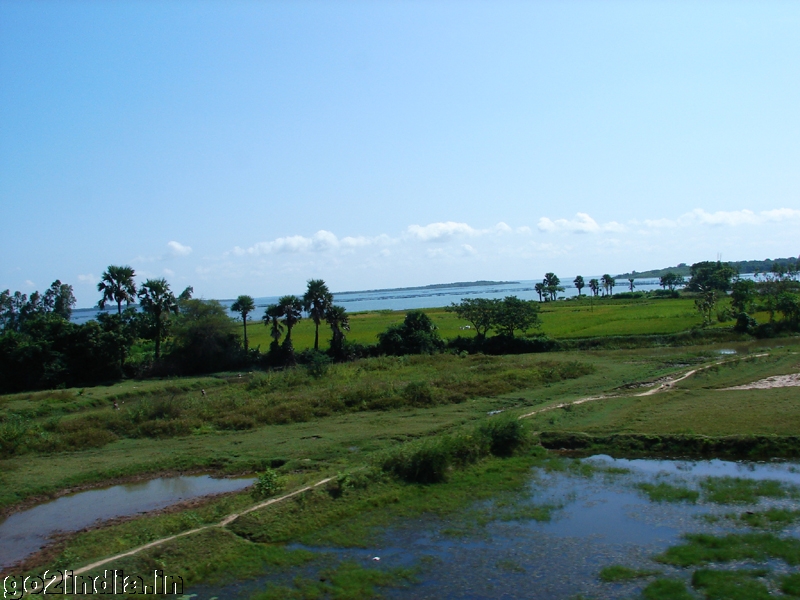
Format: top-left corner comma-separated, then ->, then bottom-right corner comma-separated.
191,456 -> 800,600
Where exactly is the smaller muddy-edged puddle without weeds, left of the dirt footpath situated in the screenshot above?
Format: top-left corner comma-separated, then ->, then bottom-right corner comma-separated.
0,475 -> 255,568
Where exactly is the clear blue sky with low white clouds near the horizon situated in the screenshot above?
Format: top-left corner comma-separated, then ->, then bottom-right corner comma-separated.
0,1 -> 800,306
